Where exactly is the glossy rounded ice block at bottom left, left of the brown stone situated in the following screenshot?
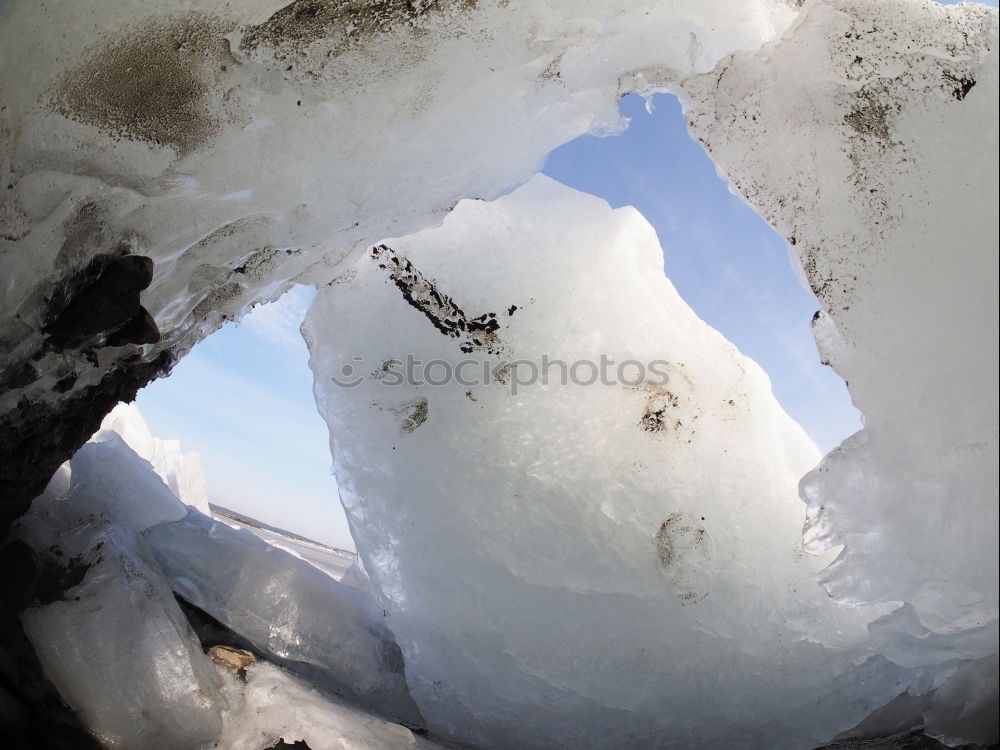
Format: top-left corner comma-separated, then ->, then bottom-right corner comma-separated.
21,522 -> 222,750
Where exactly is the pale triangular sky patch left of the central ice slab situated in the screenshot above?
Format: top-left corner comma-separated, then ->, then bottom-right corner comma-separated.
136,286 -> 364,551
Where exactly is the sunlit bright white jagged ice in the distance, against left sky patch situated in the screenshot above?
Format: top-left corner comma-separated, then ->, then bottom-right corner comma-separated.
98,404 -> 211,515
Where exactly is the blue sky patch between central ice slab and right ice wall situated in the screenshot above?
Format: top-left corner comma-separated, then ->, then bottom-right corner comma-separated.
544,95 -> 860,451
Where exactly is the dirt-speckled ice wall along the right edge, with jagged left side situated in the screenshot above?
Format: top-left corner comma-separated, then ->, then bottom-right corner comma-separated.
683,0 -> 998,676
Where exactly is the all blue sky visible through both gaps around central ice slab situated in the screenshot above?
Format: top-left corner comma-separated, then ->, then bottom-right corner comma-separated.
137,91 -> 859,549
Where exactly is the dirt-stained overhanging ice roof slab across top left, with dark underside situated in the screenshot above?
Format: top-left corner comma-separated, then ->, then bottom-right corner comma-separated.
0,0 -> 795,516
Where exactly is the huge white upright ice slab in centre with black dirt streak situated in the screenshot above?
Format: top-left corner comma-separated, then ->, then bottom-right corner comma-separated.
303,177 -> 905,748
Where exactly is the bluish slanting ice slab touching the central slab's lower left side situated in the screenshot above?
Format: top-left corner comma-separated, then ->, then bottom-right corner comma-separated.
145,510 -> 420,724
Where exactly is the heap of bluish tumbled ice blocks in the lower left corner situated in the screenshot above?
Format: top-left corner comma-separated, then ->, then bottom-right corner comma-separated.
15,409 -> 433,750
